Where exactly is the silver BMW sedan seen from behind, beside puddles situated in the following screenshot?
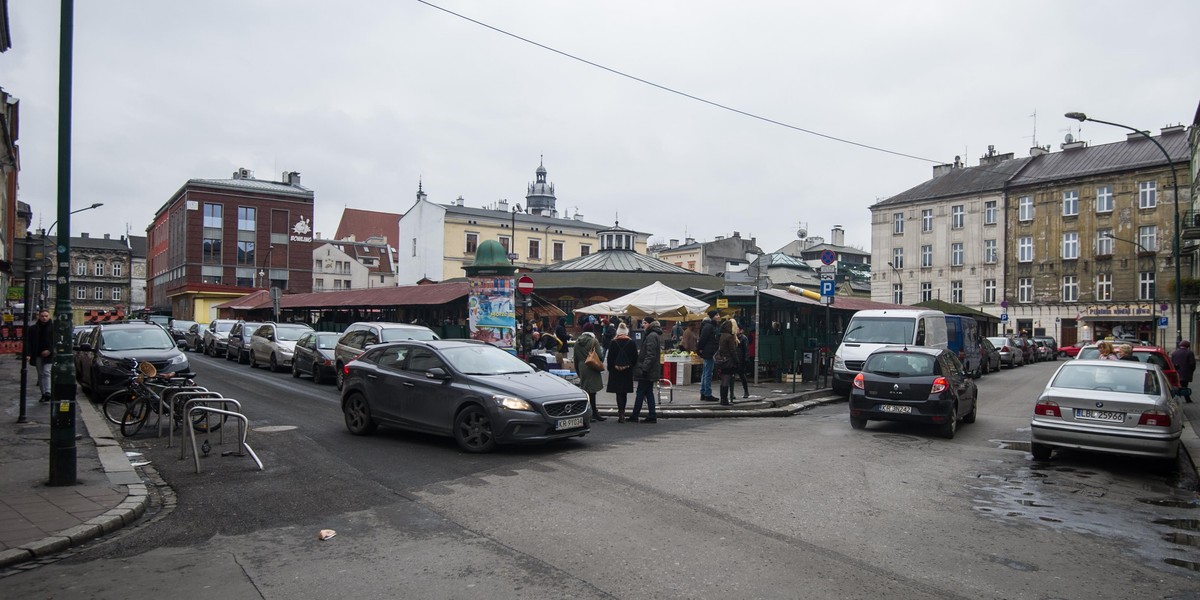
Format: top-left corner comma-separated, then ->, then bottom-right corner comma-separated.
1030,359 -> 1183,461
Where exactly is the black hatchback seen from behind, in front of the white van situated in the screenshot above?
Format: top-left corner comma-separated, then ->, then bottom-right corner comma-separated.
850,346 -> 979,438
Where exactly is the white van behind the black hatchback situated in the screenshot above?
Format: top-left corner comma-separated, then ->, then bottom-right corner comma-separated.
833,308 -> 946,395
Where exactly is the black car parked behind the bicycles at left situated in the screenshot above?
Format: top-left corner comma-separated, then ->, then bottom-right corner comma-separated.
76,322 -> 193,401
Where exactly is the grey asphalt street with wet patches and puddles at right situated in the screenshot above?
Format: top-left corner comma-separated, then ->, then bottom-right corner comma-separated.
7,353 -> 1200,600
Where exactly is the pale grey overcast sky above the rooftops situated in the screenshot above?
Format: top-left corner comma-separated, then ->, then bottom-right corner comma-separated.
0,0 -> 1200,252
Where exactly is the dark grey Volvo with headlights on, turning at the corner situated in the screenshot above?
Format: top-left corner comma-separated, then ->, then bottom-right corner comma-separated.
342,340 -> 592,452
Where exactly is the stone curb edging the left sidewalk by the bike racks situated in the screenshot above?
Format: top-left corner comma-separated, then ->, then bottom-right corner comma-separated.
0,397 -> 150,569
